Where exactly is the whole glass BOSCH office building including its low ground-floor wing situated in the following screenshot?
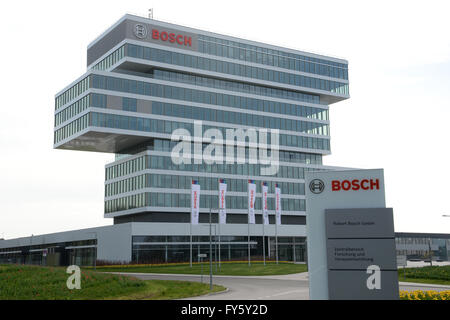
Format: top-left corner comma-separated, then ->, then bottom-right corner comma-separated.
0,15 -> 349,264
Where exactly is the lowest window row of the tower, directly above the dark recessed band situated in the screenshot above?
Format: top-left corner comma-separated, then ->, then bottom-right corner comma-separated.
105,192 -> 306,213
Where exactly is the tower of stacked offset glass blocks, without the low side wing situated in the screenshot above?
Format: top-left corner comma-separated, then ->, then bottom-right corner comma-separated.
49,15 -> 349,260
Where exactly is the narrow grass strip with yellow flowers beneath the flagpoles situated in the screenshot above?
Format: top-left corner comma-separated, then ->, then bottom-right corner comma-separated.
93,261 -> 307,276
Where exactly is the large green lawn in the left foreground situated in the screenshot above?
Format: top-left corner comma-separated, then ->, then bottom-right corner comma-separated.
0,265 -> 225,300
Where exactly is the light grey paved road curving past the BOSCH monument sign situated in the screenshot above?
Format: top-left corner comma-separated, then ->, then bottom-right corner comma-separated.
109,272 -> 450,300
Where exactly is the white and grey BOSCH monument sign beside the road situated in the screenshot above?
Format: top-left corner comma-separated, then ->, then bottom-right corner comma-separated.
305,169 -> 395,299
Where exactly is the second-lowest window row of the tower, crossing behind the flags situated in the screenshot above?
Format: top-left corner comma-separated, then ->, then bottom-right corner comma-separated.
105,174 -> 305,197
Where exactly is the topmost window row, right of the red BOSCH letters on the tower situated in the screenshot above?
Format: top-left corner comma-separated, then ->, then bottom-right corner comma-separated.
198,35 -> 348,79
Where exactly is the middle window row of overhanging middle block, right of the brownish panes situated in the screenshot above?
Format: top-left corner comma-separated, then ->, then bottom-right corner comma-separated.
152,102 -> 329,135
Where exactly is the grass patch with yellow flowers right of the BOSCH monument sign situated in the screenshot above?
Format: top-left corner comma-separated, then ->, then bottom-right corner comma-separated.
398,266 -> 450,285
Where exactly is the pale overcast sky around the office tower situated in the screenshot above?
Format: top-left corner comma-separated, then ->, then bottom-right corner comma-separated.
0,0 -> 450,239
